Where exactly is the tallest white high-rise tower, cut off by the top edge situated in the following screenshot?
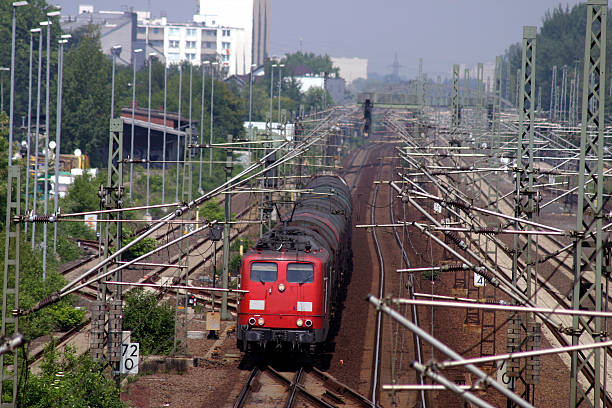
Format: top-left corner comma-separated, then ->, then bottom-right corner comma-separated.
193,0 -> 271,68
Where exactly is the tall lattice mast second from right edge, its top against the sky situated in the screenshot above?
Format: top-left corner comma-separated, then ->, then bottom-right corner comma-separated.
507,26 -> 541,402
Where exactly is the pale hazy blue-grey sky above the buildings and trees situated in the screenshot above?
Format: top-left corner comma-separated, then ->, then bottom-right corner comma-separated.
56,0 -> 580,76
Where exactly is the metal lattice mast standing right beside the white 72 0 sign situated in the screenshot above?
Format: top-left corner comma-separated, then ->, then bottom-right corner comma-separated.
89,118 -> 123,372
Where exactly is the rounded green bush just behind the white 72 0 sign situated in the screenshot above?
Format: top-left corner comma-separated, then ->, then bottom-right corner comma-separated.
123,289 -> 175,354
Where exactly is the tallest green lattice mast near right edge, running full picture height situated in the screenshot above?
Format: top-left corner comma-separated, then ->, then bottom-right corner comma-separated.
570,0 -> 608,407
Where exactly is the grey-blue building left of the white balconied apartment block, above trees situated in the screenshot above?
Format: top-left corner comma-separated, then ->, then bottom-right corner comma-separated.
61,5 -> 144,66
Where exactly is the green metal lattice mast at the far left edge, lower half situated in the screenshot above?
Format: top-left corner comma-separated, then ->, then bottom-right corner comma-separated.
0,166 -> 21,408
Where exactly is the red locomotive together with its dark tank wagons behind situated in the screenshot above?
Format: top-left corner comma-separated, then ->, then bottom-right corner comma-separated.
237,176 -> 352,351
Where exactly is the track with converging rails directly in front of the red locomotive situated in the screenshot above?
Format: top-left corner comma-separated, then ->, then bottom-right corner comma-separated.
234,365 -> 375,408
